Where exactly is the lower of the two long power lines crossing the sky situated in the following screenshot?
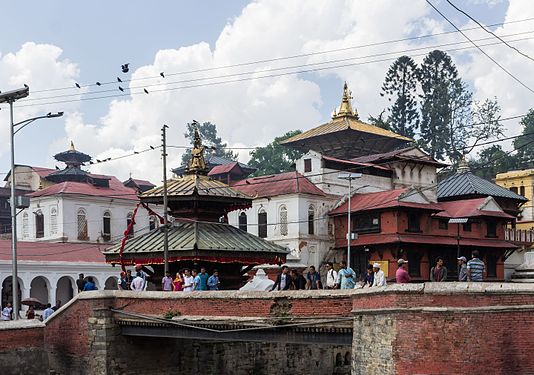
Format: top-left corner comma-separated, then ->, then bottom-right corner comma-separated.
14,30 -> 534,107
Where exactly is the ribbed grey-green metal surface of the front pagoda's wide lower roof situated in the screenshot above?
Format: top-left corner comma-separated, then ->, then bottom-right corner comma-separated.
104,222 -> 288,257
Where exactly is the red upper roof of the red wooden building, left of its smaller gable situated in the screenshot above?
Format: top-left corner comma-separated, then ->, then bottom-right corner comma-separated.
330,189 -> 442,215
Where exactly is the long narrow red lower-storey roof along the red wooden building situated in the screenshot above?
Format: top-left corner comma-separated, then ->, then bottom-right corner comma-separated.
351,233 -> 517,249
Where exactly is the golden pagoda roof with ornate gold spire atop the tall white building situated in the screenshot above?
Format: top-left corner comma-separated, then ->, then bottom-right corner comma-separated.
280,82 -> 413,160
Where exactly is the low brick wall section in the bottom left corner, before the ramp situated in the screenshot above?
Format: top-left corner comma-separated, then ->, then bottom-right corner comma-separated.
0,320 -> 49,375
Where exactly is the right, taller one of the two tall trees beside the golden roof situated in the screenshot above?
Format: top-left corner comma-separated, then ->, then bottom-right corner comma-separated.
418,50 -> 463,160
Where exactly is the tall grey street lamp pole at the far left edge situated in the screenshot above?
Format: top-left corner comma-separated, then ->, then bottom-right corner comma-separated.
9,101 -> 19,320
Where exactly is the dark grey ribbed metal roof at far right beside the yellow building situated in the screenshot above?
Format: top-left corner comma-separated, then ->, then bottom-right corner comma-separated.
438,172 -> 528,202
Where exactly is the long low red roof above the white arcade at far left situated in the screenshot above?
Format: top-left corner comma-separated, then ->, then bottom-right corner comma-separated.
0,240 -> 109,263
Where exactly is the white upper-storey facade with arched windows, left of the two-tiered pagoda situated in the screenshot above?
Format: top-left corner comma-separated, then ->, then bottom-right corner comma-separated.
17,195 -> 154,242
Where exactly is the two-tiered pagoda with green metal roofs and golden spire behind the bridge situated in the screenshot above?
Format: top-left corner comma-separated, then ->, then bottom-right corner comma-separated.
104,126 -> 288,288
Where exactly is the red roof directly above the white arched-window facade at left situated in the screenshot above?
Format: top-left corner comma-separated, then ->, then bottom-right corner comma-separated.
28,177 -> 138,200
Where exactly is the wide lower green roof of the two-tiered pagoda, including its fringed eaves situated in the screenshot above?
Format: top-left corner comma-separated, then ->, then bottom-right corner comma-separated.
104,222 -> 289,264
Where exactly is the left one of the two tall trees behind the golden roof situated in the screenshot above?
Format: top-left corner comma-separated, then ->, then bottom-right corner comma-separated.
380,56 -> 419,138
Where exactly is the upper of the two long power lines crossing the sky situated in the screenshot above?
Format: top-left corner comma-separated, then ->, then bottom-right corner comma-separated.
29,17 -> 534,93
